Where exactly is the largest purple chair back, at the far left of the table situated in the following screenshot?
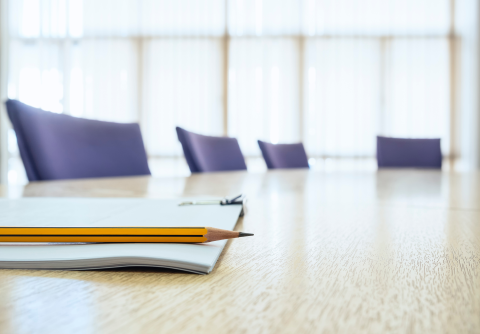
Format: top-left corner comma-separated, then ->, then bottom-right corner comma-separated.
5,100 -> 150,181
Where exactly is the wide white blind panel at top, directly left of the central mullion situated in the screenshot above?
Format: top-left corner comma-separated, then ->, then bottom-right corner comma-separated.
81,0 -> 225,37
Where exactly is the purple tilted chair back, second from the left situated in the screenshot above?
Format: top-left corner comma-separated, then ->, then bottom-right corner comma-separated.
177,126 -> 247,173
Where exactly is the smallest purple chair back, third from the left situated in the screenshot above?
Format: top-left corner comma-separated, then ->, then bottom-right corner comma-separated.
258,140 -> 309,169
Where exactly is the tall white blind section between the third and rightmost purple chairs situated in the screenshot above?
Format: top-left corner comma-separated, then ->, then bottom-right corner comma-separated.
304,38 -> 381,156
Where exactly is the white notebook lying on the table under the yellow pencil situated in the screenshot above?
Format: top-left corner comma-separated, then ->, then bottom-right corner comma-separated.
0,198 -> 242,274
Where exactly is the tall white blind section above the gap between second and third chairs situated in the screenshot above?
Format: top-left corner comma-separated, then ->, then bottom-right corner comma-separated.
228,38 -> 301,155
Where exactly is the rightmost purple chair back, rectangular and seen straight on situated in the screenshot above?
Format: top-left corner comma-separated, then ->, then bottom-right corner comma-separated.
377,136 -> 442,168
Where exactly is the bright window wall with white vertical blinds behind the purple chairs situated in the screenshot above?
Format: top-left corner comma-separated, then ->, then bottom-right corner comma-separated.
0,0 -> 480,184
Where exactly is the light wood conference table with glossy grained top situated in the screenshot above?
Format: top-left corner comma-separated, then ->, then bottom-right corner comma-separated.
0,170 -> 480,333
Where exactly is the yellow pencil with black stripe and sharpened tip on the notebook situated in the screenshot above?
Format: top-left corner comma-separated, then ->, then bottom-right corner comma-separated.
0,226 -> 253,243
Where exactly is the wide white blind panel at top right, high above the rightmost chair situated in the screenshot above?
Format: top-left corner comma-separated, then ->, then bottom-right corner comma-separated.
302,0 -> 451,36
